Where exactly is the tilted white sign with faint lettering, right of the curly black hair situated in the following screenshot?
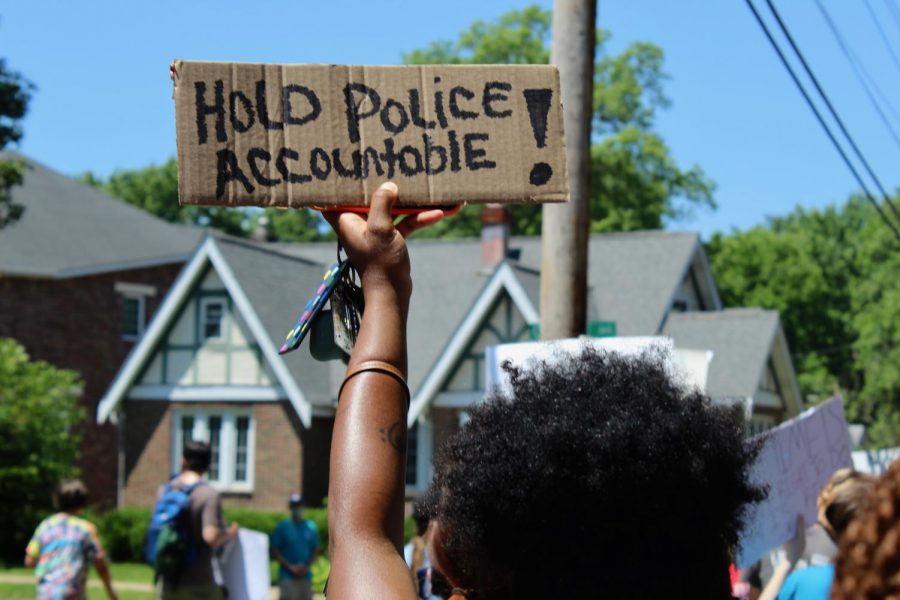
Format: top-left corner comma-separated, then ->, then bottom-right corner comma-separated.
737,398 -> 853,568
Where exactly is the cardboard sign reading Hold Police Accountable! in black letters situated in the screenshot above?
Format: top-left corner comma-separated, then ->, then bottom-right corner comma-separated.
172,61 -> 568,207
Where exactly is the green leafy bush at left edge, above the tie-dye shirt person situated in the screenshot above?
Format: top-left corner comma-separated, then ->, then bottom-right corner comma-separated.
0,338 -> 84,561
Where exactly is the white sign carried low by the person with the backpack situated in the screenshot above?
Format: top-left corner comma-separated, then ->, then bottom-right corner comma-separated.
222,528 -> 271,600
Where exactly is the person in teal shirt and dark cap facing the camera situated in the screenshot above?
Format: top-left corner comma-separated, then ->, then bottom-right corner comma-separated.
271,494 -> 319,600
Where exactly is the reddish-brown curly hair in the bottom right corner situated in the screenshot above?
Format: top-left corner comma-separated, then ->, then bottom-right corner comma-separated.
831,460 -> 900,600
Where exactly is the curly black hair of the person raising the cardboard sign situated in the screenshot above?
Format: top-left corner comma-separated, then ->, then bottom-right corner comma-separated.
424,345 -> 765,600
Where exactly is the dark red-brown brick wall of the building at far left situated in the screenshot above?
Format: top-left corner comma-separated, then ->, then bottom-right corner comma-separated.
0,263 -> 183,506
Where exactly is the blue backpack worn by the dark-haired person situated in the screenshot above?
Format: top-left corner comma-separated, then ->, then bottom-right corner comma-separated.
144,481 -> 205,582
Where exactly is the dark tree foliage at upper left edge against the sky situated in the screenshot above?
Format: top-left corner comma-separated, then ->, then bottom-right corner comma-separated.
0,59 -> 34,229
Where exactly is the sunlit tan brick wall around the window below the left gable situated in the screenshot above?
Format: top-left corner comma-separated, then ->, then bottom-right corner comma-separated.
123,399 -> 333,510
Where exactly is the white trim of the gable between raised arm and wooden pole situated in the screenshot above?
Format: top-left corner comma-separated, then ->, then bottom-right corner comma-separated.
406,262 -> 540,427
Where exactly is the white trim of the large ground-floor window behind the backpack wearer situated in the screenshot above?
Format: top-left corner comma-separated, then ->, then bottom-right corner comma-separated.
171,409 -> 256,494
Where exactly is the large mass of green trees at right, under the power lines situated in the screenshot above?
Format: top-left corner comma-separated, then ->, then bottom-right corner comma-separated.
707,197 -> 900,447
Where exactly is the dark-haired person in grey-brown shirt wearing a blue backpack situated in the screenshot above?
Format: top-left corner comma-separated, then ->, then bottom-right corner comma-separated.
152,441 -> 238,600
